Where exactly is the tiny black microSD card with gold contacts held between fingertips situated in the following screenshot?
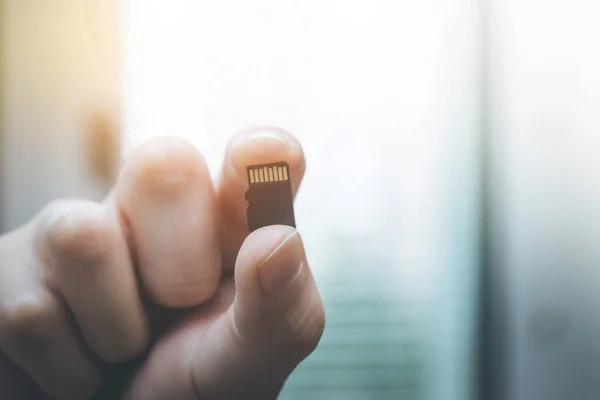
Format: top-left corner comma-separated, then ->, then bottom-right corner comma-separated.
246,162 -> 296,232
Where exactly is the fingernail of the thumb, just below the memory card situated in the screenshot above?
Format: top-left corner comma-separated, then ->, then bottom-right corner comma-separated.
258,231 -> 305,297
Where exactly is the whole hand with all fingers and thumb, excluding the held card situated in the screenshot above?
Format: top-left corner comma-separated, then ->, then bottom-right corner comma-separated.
0,128 -> 325,400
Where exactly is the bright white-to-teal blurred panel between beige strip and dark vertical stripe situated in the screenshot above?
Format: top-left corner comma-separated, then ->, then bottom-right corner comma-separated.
123,0 -> 479,400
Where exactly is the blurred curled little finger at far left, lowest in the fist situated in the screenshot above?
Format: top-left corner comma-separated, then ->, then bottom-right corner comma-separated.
0,209 -> 100,400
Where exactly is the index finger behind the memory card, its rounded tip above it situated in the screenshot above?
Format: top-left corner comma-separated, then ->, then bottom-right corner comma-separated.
217,128 -> 305,268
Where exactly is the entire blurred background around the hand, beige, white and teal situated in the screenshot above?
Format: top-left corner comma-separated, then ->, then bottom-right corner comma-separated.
0,0 -> 600,400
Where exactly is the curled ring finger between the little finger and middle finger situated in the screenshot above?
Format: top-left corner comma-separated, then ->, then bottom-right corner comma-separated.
47,201 -> 148,362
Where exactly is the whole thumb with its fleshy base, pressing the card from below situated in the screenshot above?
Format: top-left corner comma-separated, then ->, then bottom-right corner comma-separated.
119,226 -> 325,400
